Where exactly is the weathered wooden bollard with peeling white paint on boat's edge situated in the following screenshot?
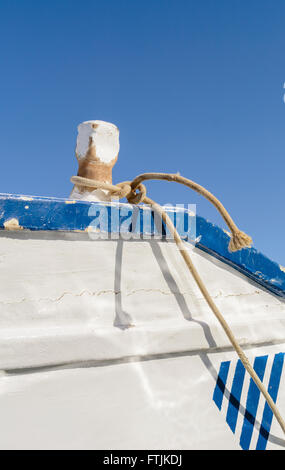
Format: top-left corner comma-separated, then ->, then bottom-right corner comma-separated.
70,121 -> 120,201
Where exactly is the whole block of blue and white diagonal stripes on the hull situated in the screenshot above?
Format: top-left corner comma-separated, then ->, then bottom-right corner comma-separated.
213,352 -> 285,450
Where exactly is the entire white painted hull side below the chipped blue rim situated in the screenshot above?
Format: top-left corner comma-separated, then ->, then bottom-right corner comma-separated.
0,231 -> 285,449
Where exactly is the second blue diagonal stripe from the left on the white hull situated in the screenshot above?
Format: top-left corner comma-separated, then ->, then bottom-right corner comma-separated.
226,360 -> 245,433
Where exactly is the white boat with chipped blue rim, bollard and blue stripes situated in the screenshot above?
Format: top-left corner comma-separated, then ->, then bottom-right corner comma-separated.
0,121 -> 285,450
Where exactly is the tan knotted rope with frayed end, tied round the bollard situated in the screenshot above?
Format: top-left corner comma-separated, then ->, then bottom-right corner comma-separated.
71,173 -> 285,434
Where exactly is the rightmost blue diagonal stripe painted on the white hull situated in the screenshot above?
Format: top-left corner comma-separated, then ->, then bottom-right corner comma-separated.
256,353 -> 285,450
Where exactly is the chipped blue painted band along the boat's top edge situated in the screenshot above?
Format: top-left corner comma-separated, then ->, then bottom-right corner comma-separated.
0,194 -> 285,297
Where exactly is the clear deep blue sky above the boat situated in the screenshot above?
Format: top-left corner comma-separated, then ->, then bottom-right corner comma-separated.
0,0 -> 285,265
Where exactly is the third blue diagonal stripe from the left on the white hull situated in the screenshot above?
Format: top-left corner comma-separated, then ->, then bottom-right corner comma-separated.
240,356 -> 268,450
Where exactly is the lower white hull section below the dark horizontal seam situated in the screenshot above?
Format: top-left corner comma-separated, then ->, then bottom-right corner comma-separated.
0,346 -> 285,450
